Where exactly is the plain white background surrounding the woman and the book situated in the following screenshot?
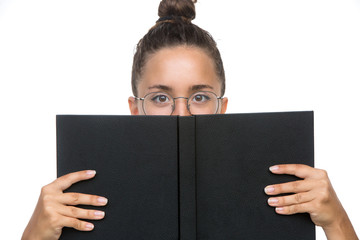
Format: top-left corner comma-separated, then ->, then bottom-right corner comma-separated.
0,0 -> 360,239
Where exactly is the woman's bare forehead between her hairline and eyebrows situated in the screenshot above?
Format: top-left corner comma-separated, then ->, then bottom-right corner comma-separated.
138,46 -> 221,95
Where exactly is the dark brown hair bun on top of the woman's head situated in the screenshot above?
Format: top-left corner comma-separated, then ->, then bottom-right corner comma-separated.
158,0 -> 196,21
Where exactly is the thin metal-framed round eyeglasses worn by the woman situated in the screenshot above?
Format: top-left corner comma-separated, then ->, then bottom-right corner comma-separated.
134,91 -> 223,115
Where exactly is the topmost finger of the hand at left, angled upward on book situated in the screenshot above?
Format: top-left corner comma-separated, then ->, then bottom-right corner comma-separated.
53,170 -> 96,191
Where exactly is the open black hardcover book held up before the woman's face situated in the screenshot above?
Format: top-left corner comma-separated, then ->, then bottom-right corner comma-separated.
57,112 -> 315,240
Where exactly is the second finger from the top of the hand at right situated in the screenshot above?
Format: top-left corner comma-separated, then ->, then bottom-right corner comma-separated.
265,180 -> 316,195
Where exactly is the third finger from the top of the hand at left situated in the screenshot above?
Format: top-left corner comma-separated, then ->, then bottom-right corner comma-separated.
58,205 -> 105,220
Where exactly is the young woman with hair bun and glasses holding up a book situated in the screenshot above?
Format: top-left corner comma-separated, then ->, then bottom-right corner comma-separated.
23,0 -> 358,240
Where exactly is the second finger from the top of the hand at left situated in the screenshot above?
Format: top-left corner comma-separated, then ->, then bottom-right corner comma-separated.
57,192 -> 108,206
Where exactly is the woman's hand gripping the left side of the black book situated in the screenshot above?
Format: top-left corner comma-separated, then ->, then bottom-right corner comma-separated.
22,170 -> 107,240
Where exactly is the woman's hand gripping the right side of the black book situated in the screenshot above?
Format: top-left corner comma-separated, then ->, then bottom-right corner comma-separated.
265,164 -> 357,239
